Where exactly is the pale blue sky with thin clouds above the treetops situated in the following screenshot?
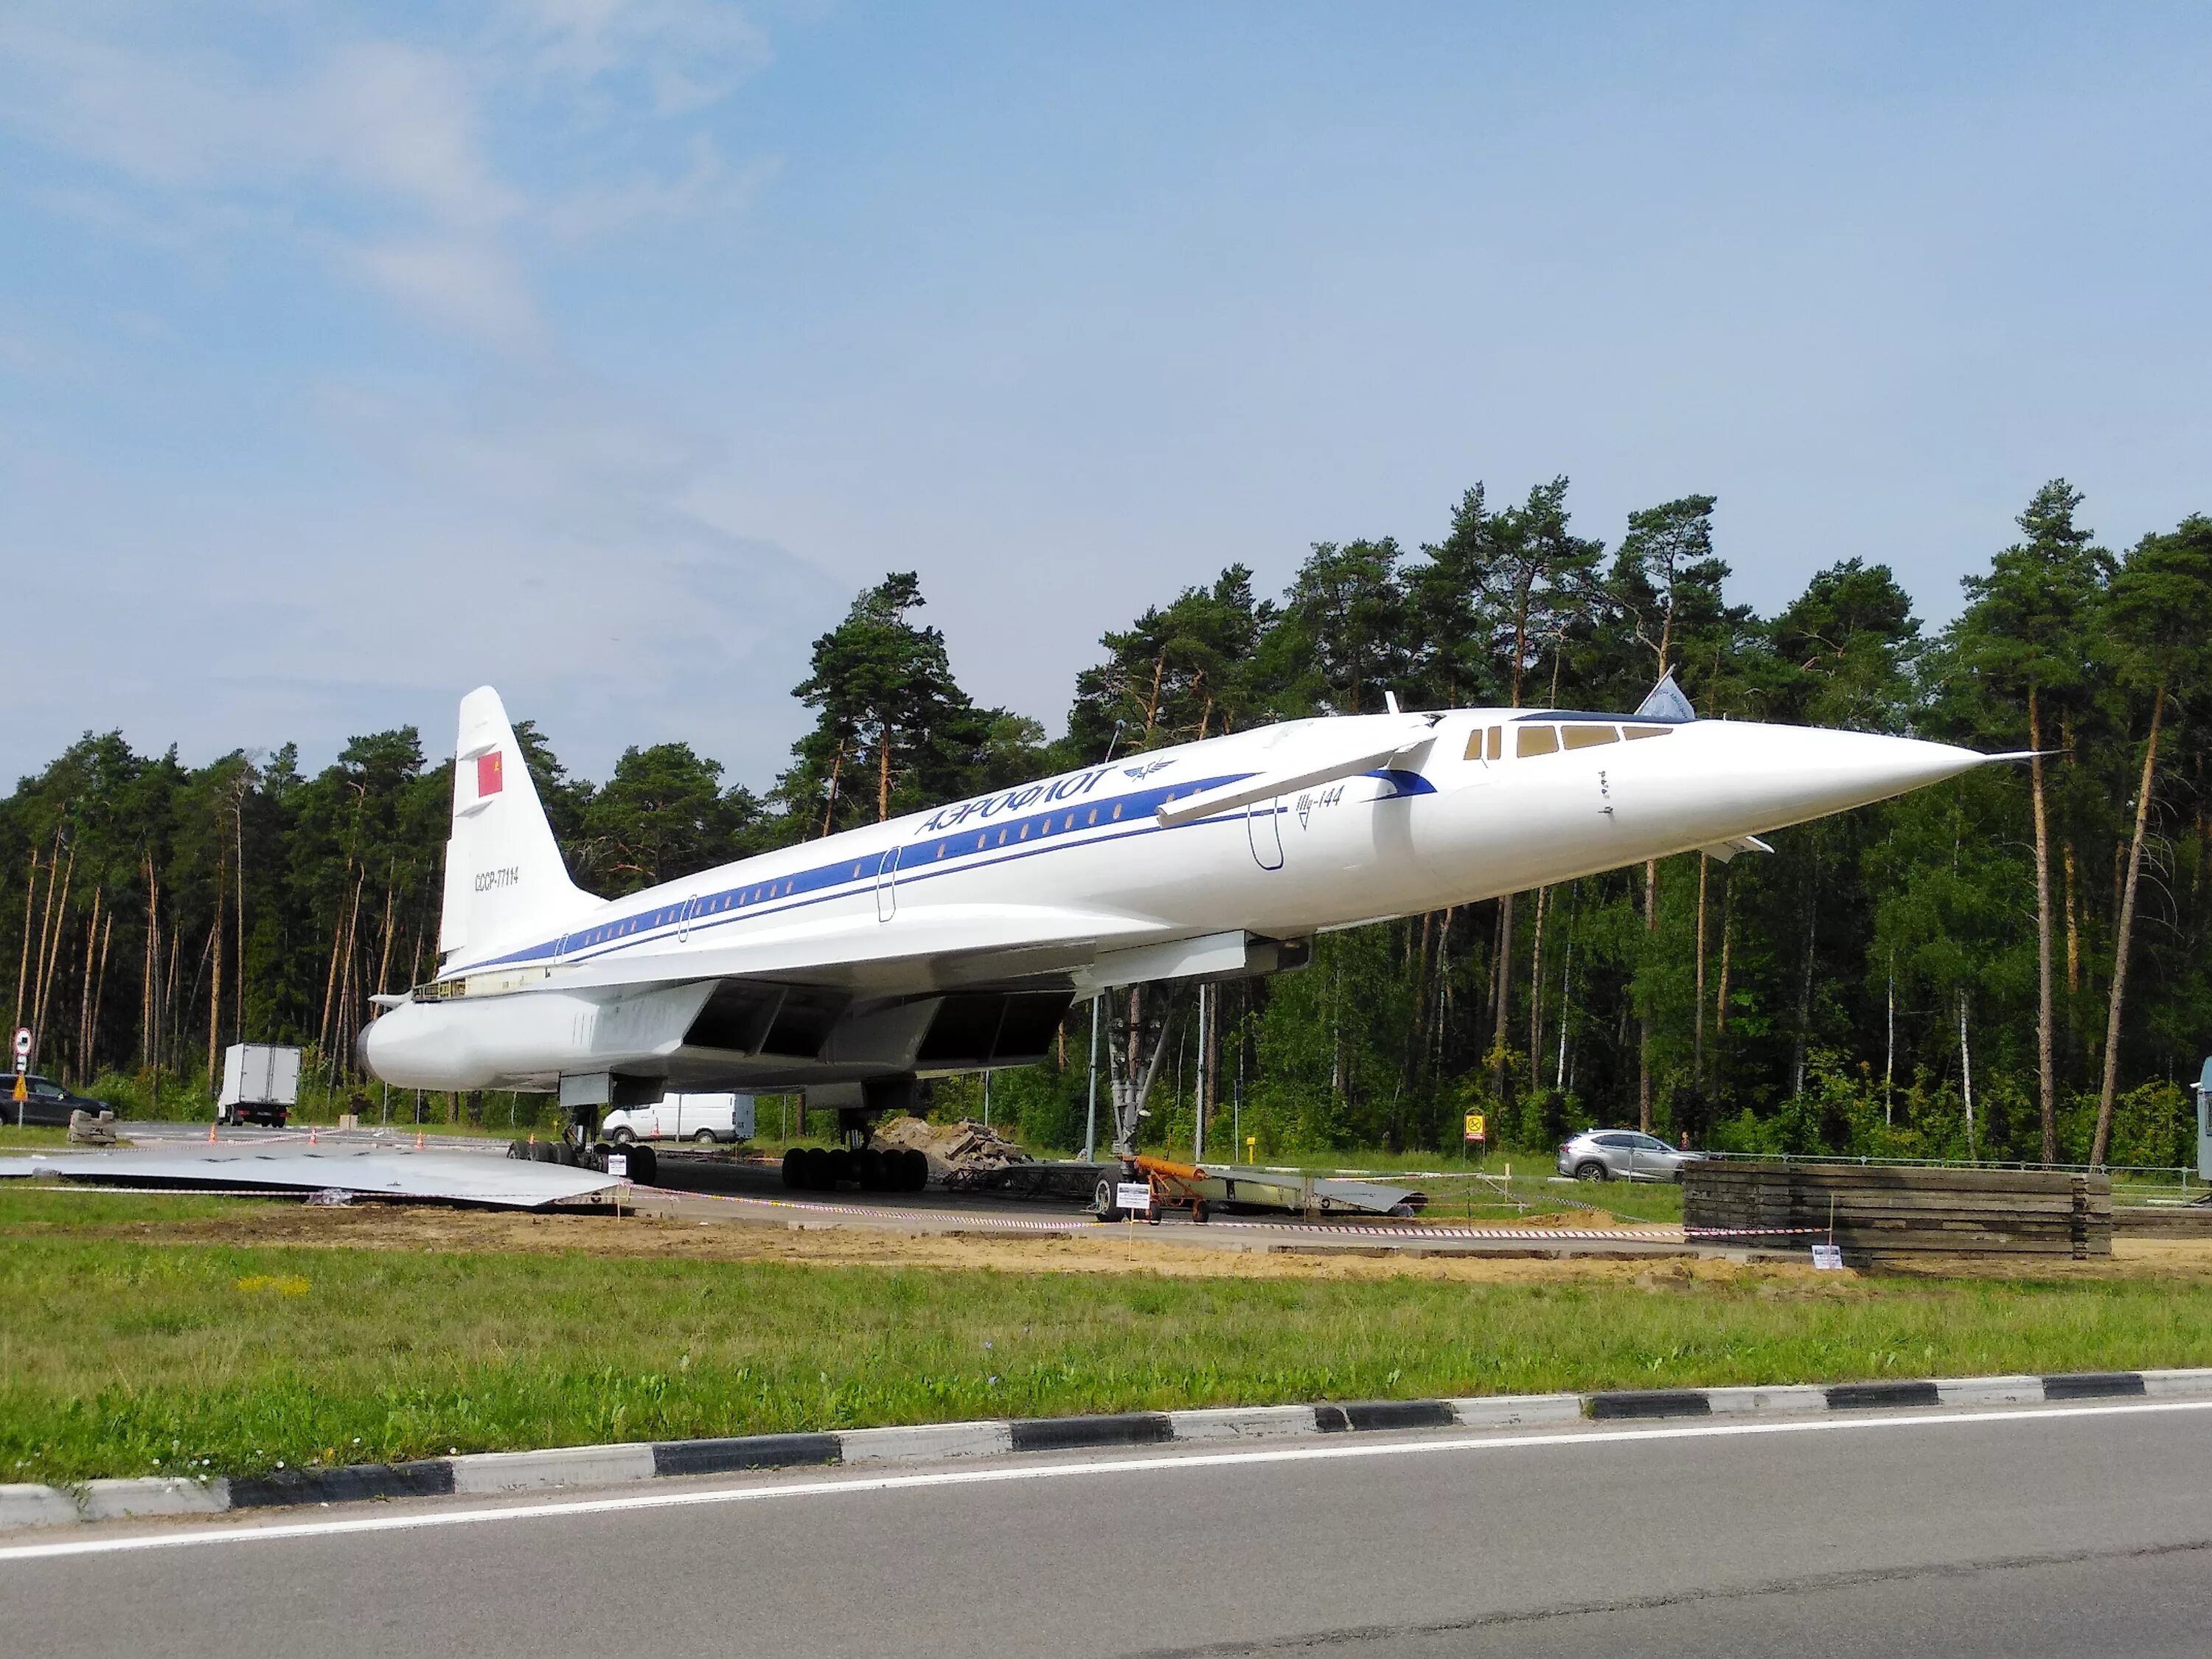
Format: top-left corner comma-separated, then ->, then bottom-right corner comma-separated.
0,0 -> 2212,785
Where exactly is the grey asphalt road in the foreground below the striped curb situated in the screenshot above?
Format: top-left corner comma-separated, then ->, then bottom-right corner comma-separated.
0,1407 -> 2212,1659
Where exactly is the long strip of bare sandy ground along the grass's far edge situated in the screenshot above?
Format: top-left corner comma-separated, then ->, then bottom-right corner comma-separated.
26,1206 -> 2212,1290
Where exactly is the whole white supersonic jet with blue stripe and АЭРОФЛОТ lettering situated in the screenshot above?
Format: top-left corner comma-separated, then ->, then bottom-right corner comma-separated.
361,679 -> 2008,1137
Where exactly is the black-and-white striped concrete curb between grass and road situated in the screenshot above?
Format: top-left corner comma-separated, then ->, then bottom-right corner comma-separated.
0,1369 -> 2212,1526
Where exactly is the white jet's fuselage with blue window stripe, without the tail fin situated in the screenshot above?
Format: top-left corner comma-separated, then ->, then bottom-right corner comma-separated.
361,710 -> 1984,1088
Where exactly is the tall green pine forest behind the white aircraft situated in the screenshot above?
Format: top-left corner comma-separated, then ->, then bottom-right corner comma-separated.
0,478 -> 2212,1166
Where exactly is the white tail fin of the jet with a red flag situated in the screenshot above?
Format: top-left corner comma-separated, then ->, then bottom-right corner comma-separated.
438,686 -> 593,962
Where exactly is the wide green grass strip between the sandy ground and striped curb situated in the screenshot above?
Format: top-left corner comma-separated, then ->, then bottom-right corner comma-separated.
0,1192 -> 2212,1482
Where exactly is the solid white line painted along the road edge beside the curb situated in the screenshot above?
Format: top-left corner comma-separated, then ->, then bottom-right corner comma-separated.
0,1400 -> 2212,1562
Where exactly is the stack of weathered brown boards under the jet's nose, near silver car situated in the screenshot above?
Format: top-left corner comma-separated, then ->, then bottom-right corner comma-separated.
1681,1159 -> 2112,1261
